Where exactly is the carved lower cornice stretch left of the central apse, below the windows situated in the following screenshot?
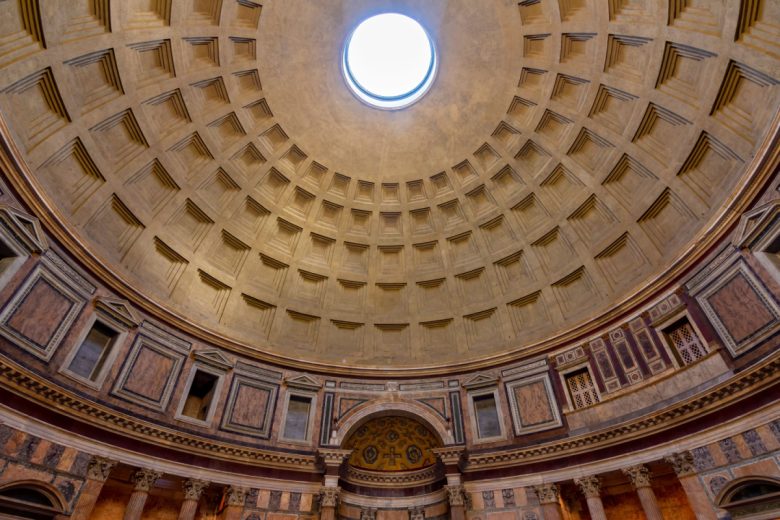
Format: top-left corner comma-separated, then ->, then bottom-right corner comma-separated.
0,355 -> 320,474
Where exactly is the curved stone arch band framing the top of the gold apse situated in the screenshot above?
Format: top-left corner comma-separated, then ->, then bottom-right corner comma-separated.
331,399 -> 455,446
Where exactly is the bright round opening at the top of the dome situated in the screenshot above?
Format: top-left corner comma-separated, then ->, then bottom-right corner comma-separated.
342,13 -> 437,109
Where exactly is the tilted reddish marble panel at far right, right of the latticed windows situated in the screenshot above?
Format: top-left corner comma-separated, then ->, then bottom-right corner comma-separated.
707,273 -> 774,343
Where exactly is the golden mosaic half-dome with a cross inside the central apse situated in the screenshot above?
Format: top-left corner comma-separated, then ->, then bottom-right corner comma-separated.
344,417 -> 440,471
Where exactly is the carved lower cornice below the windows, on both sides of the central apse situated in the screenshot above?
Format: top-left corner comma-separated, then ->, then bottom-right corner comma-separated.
0,352 -> 780,475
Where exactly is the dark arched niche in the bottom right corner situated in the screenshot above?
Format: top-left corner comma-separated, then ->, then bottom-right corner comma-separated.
715,476 -> 780,520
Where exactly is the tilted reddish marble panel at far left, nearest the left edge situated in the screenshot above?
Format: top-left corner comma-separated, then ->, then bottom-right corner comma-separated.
7,278 -> 74,348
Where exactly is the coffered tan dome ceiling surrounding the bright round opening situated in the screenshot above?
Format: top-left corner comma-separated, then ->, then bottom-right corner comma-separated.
3,0 -> 776,371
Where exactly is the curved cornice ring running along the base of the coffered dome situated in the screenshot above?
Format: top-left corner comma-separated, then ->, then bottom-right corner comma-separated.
0,113 -> 780,378
